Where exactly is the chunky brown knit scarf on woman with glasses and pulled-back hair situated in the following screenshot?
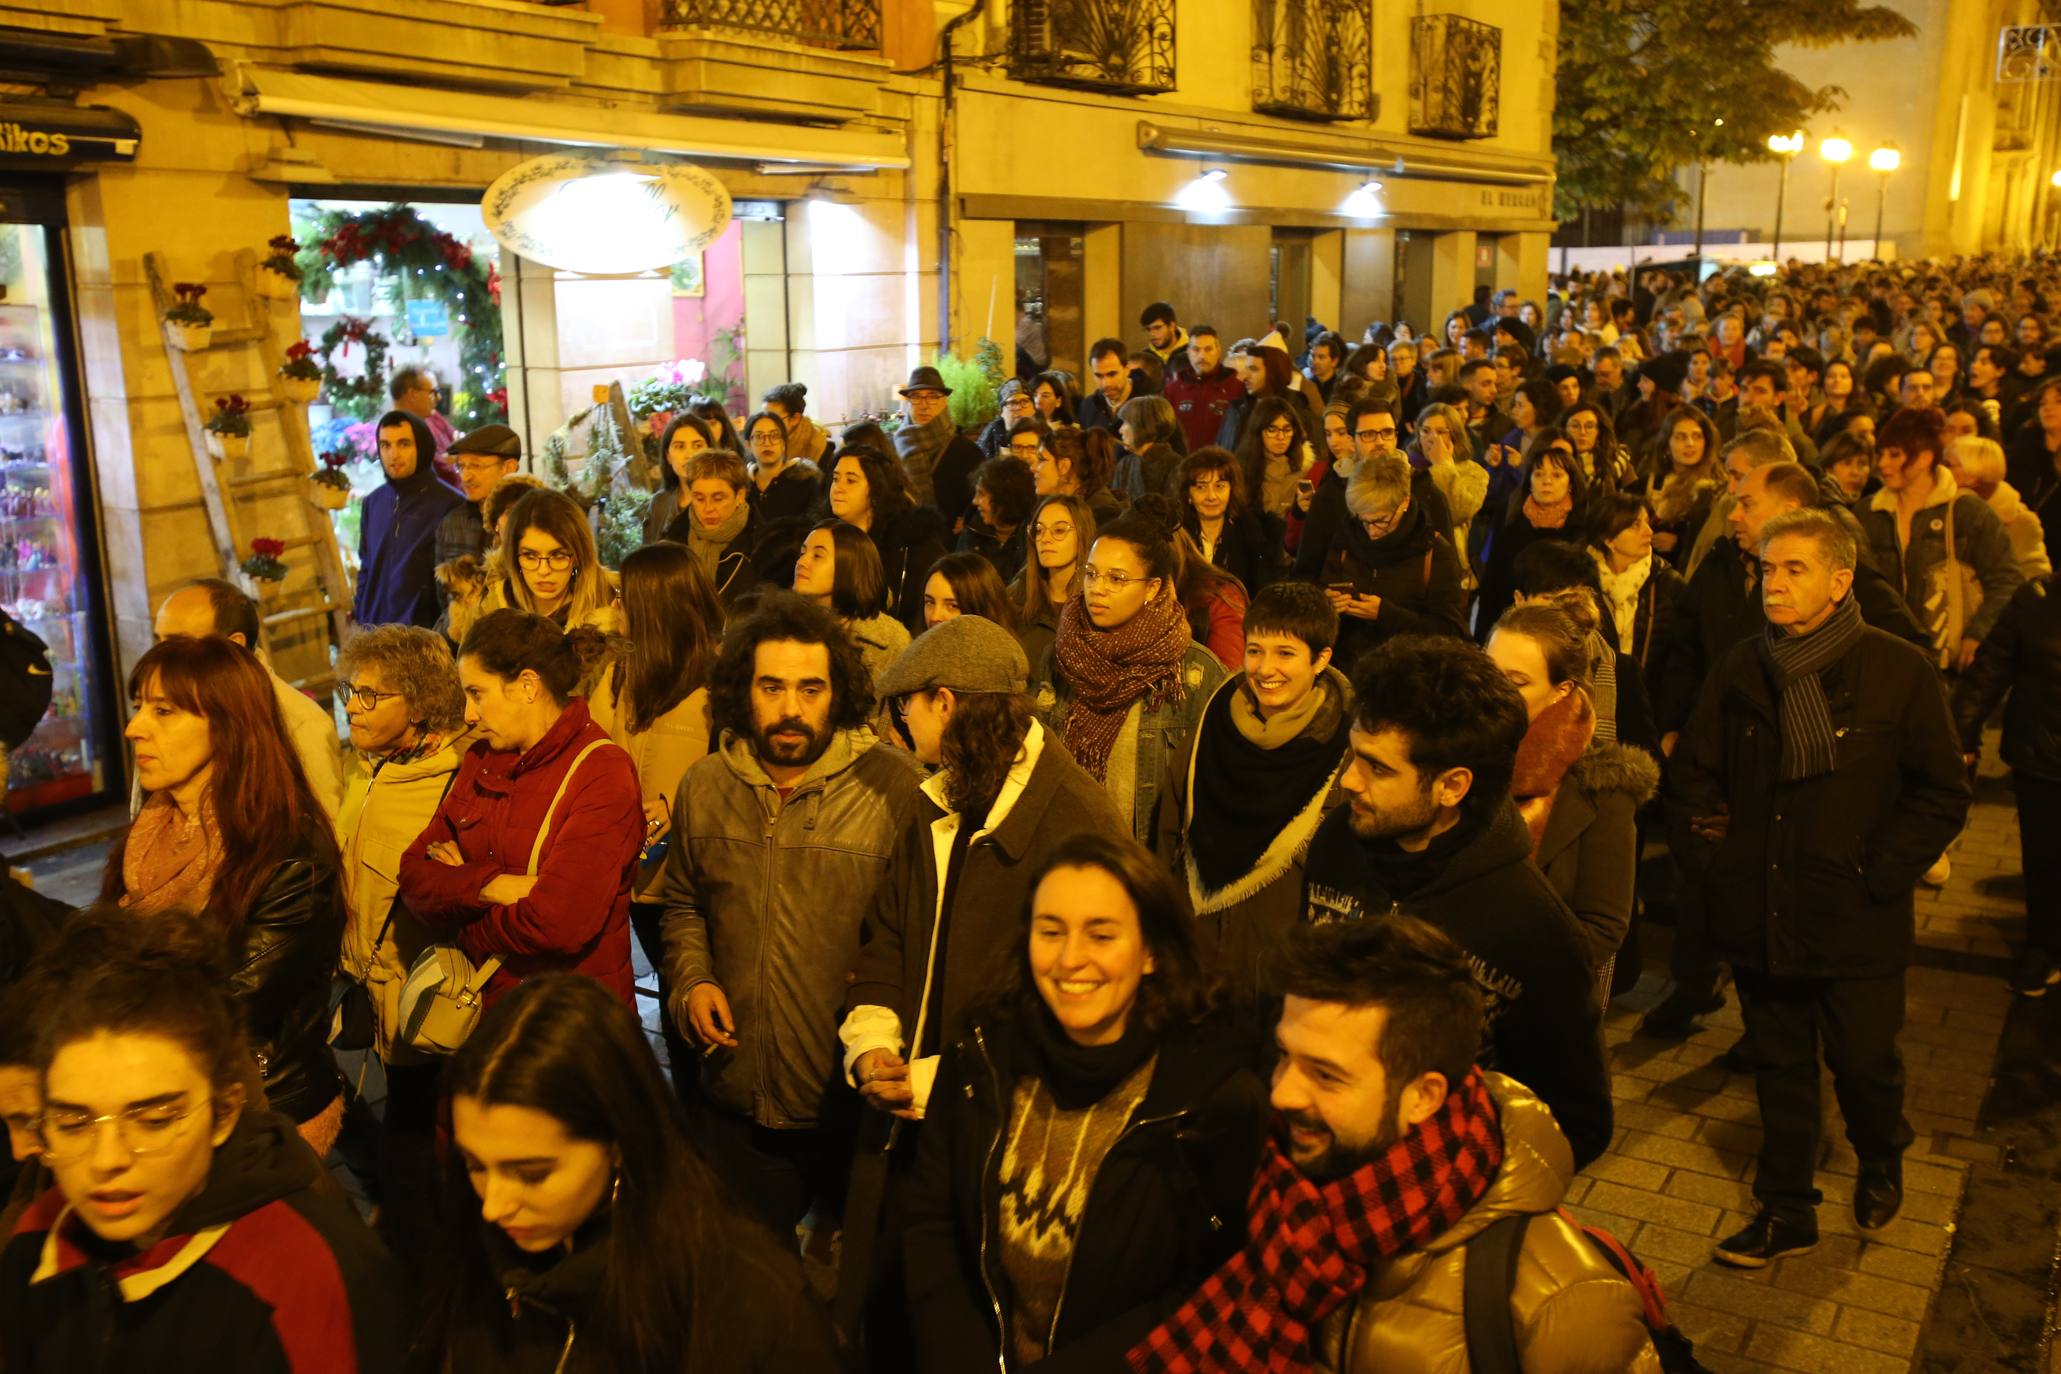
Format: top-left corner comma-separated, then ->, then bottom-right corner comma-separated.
1051,583 -> 1195,783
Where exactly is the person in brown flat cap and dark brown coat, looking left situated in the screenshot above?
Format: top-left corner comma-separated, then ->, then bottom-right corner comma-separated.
837,616 -> 1123,1368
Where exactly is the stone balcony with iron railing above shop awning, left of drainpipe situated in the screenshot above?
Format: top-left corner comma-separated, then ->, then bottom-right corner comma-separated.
657,0 -> 888,124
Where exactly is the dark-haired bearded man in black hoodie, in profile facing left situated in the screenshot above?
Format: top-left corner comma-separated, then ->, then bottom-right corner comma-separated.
1303,634 -> 1612,1168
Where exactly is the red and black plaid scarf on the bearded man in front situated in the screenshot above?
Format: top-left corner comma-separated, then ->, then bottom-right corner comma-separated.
1129,1069 -> 1502,1374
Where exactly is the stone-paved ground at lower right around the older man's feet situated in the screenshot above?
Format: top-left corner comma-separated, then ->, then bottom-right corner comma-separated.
1568,740 -> 2034,1374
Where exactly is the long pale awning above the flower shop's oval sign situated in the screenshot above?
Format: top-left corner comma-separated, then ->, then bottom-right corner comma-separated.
223,62 -> 909,171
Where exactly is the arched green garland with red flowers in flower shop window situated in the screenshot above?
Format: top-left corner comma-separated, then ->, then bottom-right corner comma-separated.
299,204 -> 507,431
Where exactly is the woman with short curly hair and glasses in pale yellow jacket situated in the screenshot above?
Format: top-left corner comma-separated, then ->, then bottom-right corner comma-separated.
332,624 -> 472,1267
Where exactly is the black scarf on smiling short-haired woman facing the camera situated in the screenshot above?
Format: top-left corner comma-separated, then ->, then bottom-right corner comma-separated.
1187,678 -> 1352,892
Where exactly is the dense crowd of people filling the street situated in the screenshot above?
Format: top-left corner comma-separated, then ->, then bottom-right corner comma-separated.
0,260 -> 2061,1374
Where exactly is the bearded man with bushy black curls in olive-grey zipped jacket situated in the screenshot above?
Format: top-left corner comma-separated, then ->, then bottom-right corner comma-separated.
664,591 -> 921,1238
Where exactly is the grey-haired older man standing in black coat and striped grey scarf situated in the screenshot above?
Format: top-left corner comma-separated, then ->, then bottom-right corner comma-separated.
1667,511 -> 1970,1269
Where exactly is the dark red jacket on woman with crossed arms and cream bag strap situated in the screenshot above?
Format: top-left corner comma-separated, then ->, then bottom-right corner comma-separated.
400,698 -> 643,1007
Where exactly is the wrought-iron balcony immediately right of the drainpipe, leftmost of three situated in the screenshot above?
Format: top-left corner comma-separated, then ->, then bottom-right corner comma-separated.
1010,0 -> 1175,95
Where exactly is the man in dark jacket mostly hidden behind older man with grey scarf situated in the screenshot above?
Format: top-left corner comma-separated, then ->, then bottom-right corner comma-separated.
1638,461 -> 1931,1038
